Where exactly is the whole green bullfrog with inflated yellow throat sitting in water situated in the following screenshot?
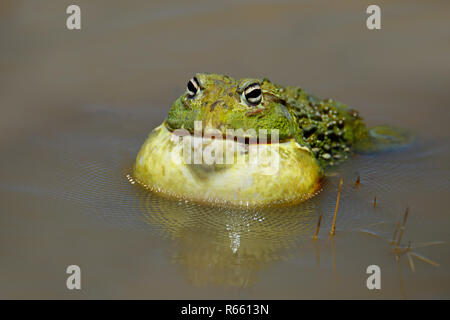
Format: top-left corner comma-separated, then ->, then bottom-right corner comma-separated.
134,73 -> 408,207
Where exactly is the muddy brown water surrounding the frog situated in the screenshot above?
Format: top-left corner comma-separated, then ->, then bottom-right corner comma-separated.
0,1 -> 450,299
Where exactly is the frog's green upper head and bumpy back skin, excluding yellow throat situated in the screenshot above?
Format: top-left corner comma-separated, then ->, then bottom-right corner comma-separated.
166,73 -> 374,167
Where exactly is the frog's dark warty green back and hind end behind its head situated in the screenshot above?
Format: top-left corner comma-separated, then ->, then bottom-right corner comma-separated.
274,82 -> 412,167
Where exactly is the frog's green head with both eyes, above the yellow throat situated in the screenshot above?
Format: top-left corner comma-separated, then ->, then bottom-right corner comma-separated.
166,73 -> 296,140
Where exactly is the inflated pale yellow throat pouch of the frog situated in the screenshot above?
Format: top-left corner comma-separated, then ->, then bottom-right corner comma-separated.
134,125 -> 322,206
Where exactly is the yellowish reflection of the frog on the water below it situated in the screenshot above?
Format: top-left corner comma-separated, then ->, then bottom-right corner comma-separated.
141,195 -> 318,287
